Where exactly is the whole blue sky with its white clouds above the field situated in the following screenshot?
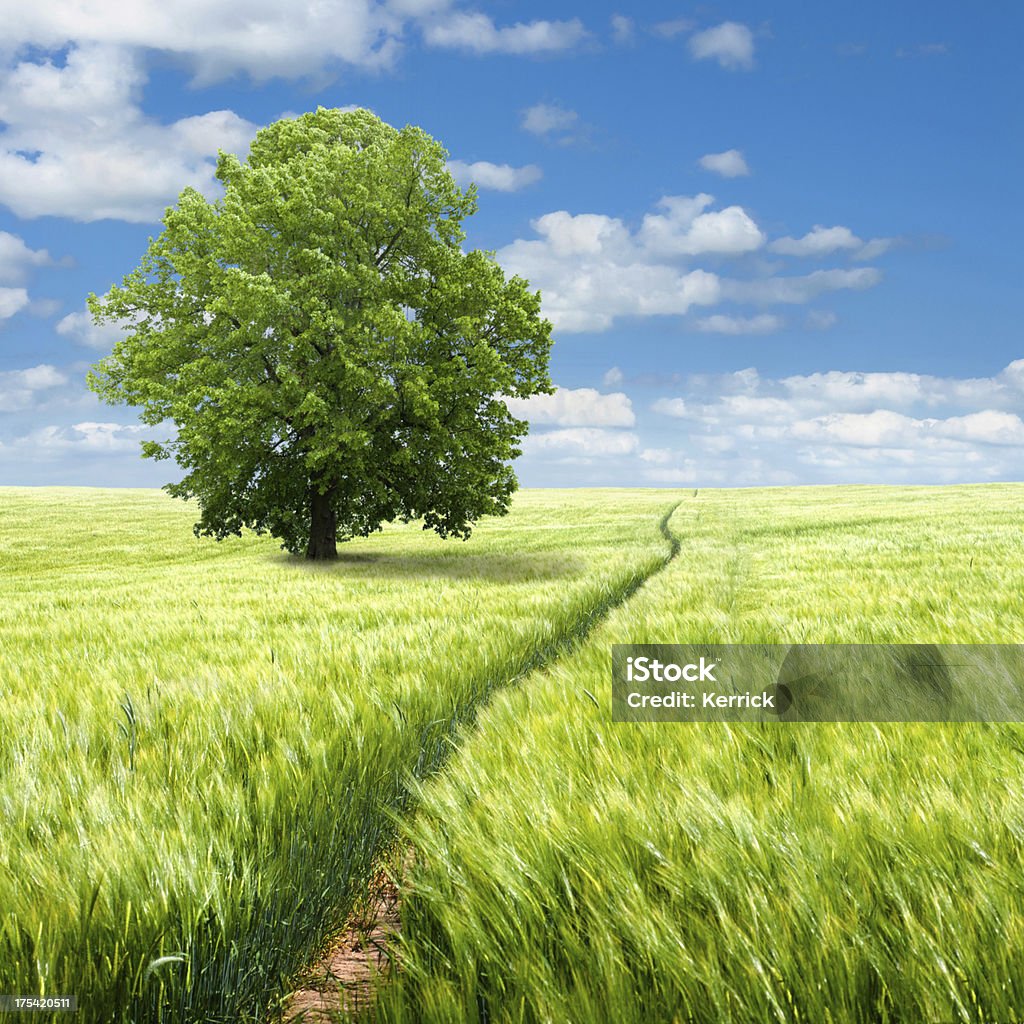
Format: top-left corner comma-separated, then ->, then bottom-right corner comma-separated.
0,0 -> 1024,486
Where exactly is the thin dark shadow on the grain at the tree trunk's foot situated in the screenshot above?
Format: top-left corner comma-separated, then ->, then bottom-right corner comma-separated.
272,551 -> 587,583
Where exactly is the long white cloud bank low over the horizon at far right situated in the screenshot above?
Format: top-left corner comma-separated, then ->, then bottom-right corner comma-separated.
638,359 -> 1024,484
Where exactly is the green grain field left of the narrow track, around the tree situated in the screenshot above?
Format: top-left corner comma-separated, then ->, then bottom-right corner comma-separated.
0,488 -> 671,1024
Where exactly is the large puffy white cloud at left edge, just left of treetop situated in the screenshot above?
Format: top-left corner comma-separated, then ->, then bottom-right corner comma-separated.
0,45 -> 256,222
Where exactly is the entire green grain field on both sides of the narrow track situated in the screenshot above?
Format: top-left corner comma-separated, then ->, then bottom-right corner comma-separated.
0,484 -> 1024,1024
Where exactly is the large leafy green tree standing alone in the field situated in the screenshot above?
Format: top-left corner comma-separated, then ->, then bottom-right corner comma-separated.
89,108 -> 552,559
